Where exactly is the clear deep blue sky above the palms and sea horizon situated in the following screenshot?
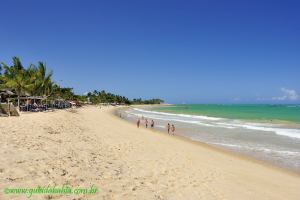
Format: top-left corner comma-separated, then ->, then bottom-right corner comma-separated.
0,0 -> 300,104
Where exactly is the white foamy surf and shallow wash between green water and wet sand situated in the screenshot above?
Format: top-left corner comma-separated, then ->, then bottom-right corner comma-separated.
118,106 -> 300,172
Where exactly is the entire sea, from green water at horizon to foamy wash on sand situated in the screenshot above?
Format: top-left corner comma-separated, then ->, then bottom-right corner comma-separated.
119,104 -> 300,172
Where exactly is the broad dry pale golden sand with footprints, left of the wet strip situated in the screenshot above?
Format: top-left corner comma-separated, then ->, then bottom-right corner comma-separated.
0,106 -> 300,200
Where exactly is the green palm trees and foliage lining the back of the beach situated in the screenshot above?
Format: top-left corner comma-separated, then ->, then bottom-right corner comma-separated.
0,57 -> 163,104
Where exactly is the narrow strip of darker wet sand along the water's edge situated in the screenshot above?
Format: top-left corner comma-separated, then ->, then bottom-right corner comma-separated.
110,105 -> 300,178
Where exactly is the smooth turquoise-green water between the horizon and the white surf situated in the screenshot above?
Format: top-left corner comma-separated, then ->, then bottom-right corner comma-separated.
153,104 -> 300,124
